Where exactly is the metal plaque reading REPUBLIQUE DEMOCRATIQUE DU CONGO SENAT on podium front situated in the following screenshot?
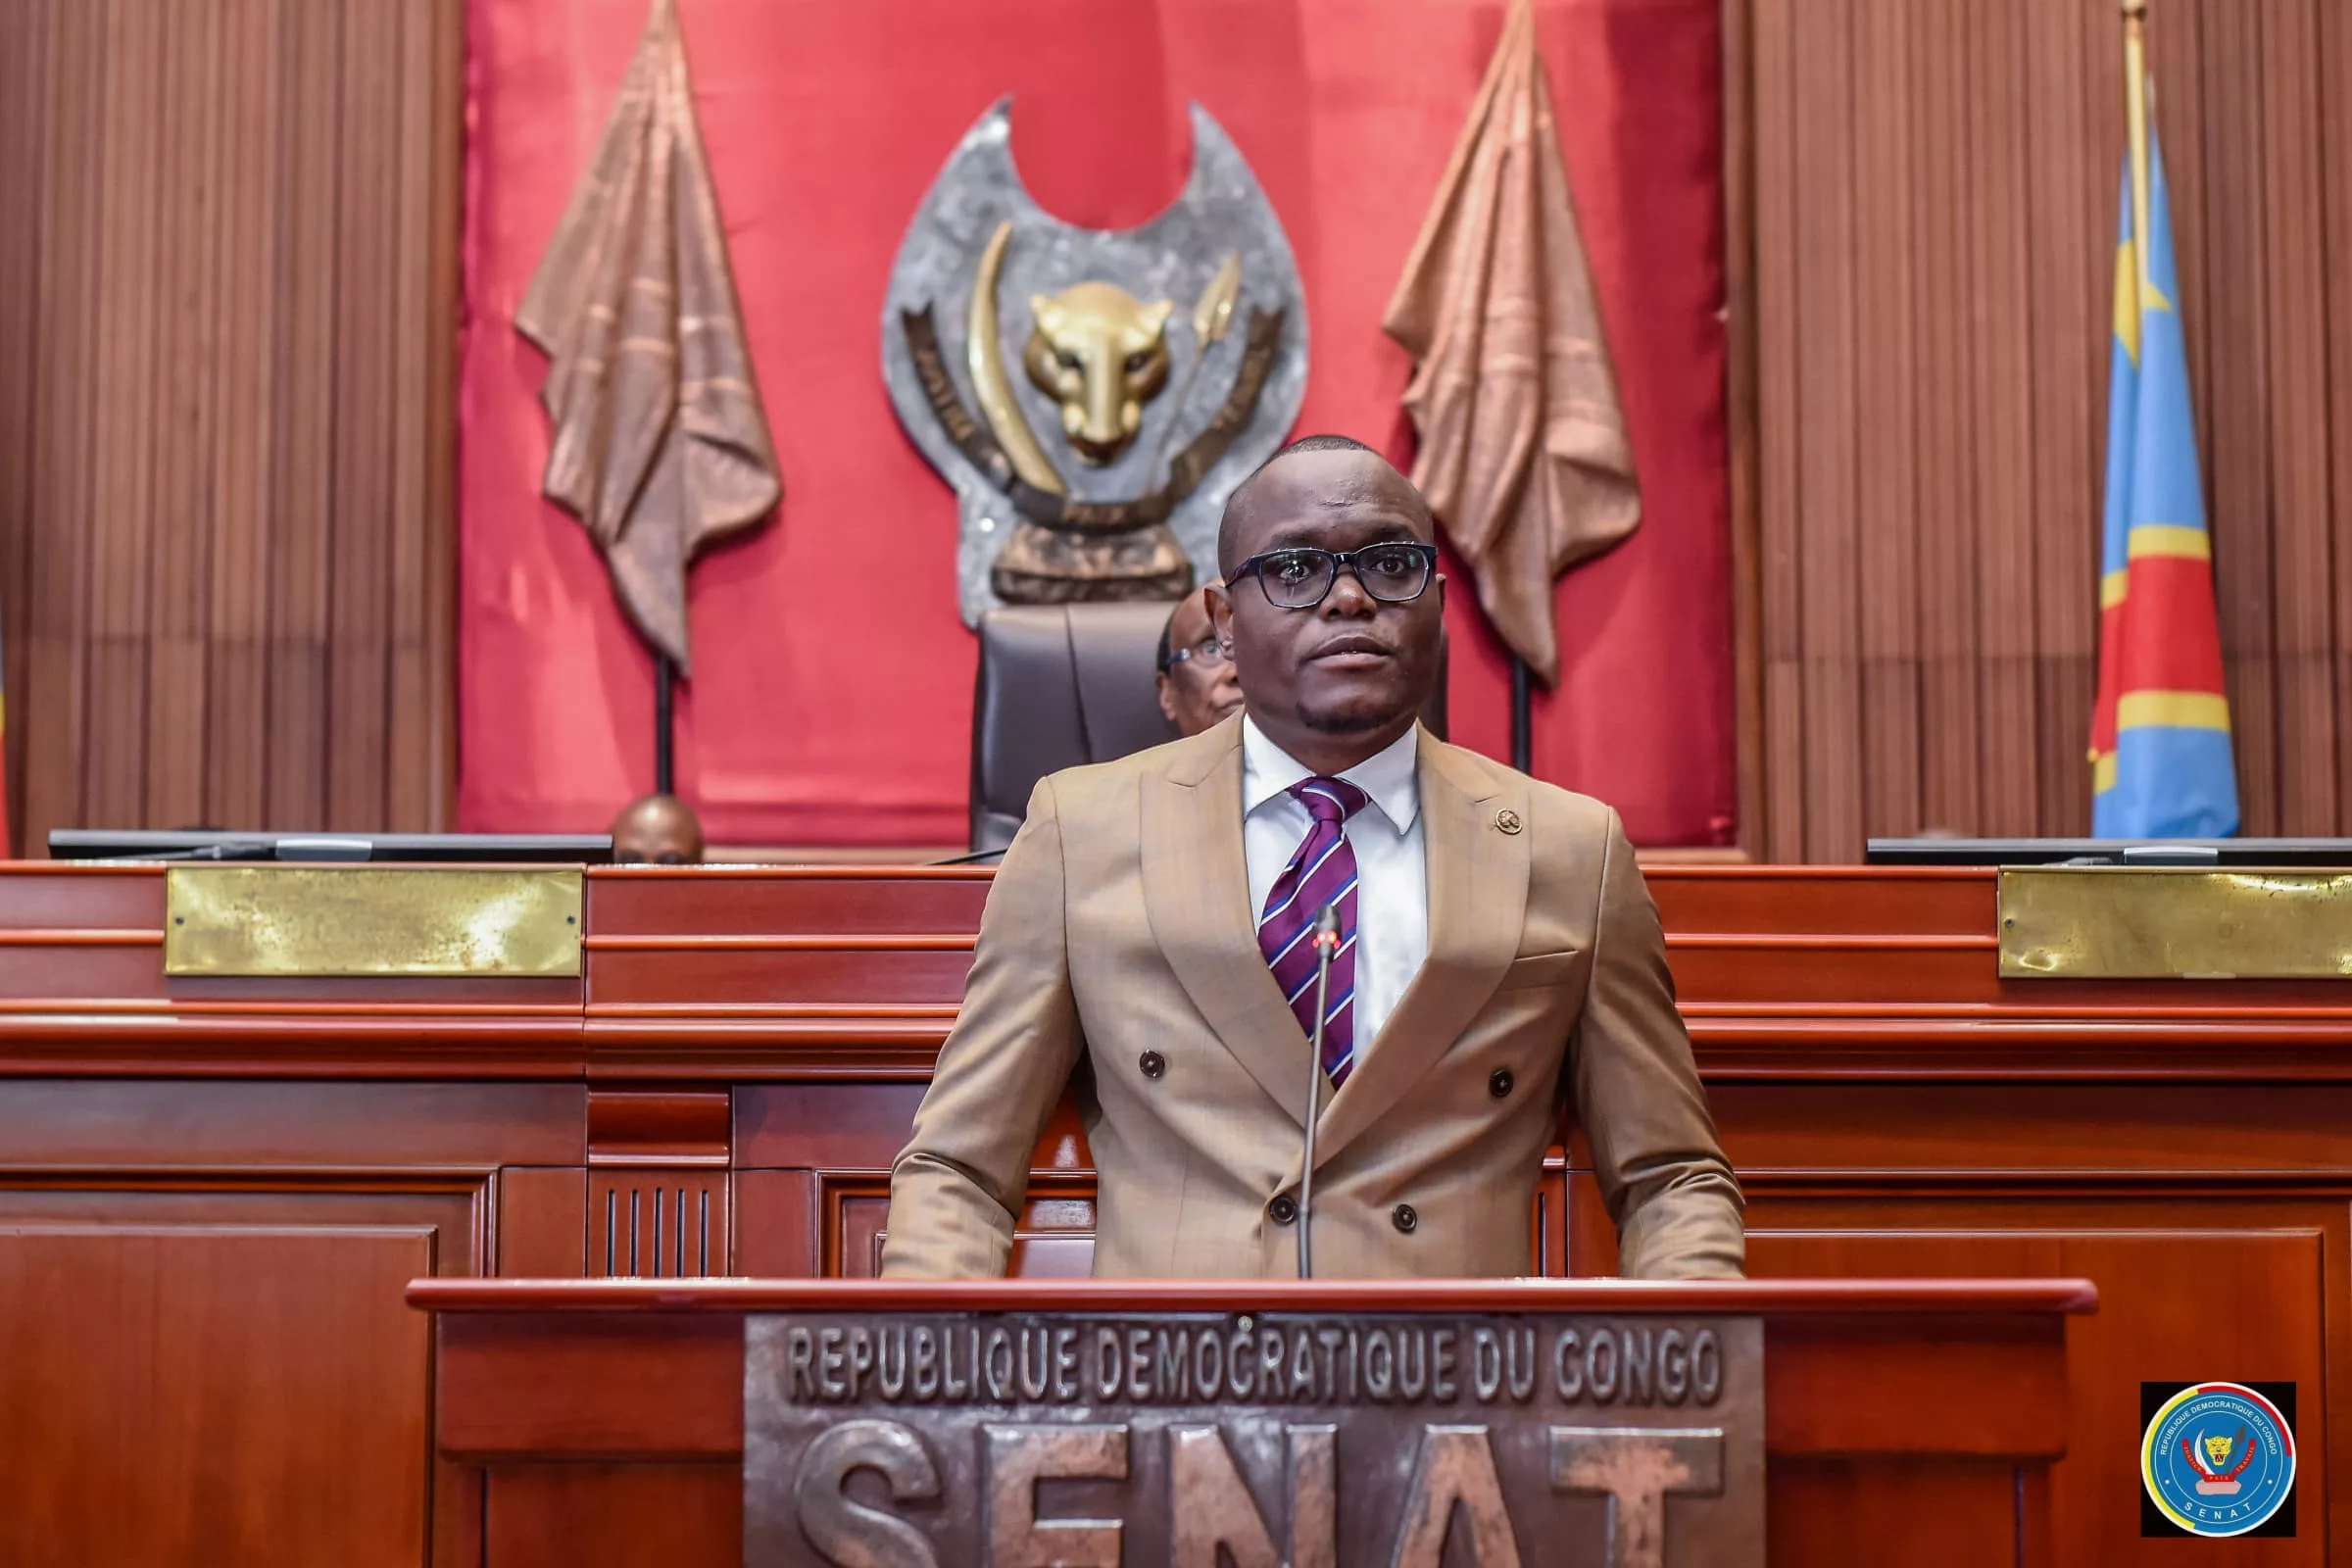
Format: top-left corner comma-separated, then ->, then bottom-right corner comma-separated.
743,1312 -> 1764,1568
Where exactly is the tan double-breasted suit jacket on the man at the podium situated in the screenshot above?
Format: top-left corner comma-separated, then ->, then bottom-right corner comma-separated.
882,719 -> 1742,1279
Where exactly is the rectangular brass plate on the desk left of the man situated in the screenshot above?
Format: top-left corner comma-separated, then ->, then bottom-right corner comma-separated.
163,865 -> 581,976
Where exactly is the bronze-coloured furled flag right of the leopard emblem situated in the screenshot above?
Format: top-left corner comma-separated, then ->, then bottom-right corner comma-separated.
1381,0 -> 1642,686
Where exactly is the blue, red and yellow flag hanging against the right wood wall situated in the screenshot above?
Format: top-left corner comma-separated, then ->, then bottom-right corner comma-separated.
2091,131 -> 2236,839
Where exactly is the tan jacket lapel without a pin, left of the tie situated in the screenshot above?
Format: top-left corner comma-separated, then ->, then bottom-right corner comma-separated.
1141,719 -> 1329,1126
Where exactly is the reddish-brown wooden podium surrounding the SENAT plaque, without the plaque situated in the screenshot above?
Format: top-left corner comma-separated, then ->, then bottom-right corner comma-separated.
410,1279 -> 2098,1568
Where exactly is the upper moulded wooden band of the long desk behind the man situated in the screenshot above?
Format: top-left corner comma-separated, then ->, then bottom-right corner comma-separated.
0,865 -> 2352,1081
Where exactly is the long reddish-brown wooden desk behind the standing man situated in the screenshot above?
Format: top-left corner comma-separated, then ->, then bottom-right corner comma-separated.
0,862 -> 2352,1568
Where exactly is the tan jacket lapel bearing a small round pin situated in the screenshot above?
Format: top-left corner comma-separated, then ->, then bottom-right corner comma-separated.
1307,731 -> 1529,1168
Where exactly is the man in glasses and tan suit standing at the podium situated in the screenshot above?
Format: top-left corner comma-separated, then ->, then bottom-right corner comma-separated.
882,437 -> 1742,1279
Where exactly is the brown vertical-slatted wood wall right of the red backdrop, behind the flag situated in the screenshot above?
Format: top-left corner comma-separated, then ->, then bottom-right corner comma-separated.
1729,0 -> 2352,860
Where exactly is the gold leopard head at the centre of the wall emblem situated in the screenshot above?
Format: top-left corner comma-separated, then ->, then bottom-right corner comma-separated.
1021,282 -> 1174,467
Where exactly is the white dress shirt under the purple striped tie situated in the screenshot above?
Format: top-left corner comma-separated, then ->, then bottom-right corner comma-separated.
1242,717 -> 1430,1060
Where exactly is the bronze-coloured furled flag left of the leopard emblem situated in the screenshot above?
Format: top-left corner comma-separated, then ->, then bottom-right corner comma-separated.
515,0 -> 783,672
